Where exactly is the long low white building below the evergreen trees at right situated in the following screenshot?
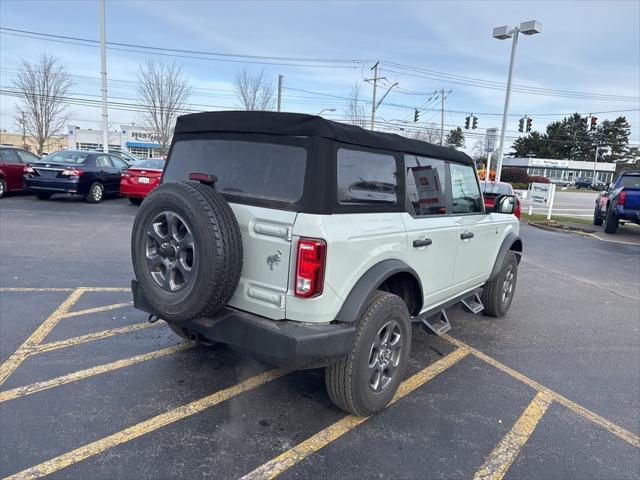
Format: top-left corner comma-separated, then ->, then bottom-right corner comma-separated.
502,157 -> 616,183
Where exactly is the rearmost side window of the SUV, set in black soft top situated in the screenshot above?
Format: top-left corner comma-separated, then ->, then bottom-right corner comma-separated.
338,148 -> 398,205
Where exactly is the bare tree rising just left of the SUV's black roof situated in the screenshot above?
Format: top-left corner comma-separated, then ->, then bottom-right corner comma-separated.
138,60 -> 191,154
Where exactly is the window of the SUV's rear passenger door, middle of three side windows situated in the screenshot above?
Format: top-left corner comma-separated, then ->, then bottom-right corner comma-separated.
404,155 -> 451,216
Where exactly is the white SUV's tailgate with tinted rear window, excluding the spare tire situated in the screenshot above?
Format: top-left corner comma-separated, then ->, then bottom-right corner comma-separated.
162,137 -> 307,320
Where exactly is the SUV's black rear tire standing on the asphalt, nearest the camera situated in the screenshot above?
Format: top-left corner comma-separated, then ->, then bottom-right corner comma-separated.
324,291 -> 411,416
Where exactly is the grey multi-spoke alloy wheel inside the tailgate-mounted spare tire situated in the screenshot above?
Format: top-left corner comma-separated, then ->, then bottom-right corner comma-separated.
146,210 -> 196,293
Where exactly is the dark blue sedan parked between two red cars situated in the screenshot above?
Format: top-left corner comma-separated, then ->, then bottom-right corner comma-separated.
24,150 -> 129,203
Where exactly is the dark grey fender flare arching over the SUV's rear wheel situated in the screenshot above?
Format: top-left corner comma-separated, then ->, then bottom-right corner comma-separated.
334,259 -> 422,323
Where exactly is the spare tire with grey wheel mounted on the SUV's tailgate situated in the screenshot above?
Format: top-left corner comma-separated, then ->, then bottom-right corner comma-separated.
131,182 -> 242,323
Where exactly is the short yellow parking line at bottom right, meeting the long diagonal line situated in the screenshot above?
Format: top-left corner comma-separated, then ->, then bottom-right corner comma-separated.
473,392 -> 553,480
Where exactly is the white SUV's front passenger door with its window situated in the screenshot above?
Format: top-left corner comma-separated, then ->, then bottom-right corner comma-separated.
449,163 -> 500,293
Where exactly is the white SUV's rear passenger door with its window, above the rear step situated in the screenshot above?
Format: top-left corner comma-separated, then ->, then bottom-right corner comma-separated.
402,155 -> 459,307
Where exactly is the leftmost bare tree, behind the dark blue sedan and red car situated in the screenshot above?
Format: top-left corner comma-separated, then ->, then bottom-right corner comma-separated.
13,54 -> 73,155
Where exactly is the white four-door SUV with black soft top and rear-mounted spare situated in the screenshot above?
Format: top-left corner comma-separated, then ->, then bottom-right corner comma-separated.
131,112 -> 522,415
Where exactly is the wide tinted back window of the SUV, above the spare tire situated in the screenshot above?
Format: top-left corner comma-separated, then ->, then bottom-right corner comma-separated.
164,139 -> 307,202
